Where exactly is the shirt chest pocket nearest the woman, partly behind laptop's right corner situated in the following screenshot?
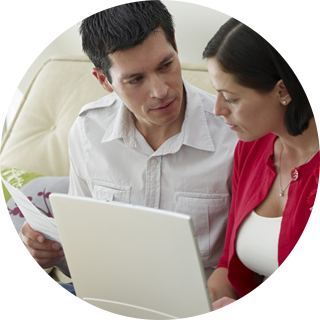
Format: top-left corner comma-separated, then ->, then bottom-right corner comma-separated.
175,192 -> 230,257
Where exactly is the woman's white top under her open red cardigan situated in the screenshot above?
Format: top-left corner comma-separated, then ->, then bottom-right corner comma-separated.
236,211 -> 285,308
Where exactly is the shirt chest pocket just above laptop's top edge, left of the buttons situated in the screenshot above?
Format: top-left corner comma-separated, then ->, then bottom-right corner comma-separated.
92,181 -> 131,203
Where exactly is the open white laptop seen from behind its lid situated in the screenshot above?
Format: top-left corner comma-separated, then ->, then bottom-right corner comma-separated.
50,194 -> 214,320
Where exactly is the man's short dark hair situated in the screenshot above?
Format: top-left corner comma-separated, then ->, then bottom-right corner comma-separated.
79,0 -> 177,83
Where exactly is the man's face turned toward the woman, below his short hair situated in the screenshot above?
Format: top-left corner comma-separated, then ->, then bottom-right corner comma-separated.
95,29 -> 185,136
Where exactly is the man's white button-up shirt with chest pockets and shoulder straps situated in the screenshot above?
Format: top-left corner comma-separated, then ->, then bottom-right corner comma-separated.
69,82 -> 237,268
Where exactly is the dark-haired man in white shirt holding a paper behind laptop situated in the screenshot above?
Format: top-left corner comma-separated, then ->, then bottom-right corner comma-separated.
0,0 -> 237,319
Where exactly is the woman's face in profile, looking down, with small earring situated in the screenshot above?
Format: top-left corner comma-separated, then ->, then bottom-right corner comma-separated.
207,57 -> 291,141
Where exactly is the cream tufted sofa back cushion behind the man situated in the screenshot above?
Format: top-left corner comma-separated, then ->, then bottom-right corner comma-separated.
0,56 -> 218,286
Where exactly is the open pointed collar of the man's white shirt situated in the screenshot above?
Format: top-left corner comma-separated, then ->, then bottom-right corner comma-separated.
101,81 -> 215,155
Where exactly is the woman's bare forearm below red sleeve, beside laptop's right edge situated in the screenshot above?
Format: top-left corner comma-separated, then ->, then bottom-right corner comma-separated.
207,268 -> 240,302
